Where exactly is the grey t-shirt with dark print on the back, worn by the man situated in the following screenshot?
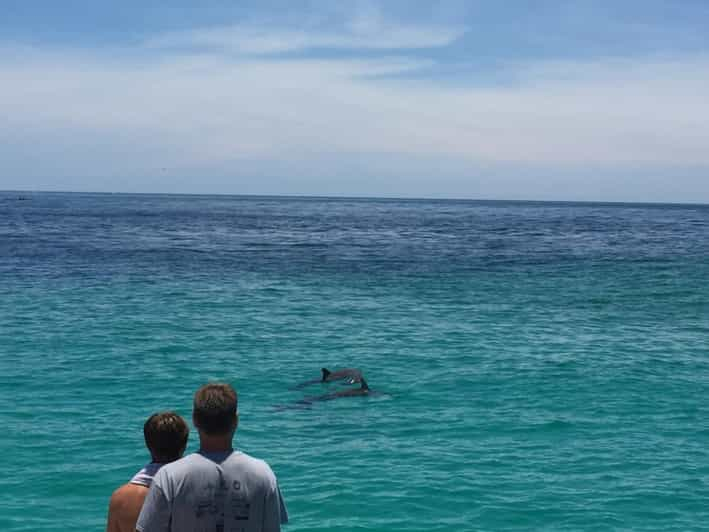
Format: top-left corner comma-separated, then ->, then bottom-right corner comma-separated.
136,451 -> 288,532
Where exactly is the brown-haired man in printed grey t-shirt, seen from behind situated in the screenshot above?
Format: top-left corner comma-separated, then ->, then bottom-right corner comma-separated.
136,384 -> 288,532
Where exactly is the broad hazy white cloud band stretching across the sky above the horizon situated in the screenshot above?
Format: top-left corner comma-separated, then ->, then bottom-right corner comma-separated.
0,36 -> 709,200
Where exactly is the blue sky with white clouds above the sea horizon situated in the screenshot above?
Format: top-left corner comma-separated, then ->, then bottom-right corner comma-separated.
0,0 -> 709,203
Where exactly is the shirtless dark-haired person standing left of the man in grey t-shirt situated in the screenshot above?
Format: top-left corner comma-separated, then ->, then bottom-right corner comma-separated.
106,412 -> 189,532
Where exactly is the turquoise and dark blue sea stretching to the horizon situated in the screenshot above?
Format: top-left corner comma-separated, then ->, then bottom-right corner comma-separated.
0,193 -> 709,532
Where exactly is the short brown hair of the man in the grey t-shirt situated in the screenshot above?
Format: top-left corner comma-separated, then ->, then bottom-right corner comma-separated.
193,383 -> 237,436
